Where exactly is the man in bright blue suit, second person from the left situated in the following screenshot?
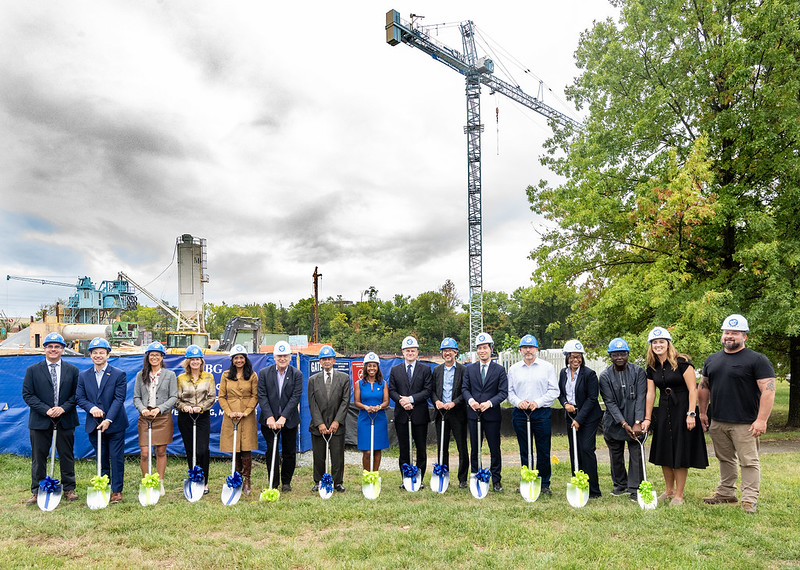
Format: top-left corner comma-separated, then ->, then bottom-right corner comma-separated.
76,336 -> 128,503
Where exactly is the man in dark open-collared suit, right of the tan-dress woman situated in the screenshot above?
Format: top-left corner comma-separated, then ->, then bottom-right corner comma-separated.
258,340 -> 303,492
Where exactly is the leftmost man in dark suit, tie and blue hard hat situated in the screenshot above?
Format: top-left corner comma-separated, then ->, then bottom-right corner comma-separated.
22,333 -> 78,506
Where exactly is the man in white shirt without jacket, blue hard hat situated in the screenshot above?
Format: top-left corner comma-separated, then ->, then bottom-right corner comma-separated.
508,334 -> 559,495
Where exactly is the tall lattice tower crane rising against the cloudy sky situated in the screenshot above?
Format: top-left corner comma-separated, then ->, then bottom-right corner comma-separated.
386,10 -> 581,351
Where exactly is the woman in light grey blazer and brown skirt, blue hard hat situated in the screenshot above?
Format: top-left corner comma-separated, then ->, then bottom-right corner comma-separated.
133,341 -> 178,496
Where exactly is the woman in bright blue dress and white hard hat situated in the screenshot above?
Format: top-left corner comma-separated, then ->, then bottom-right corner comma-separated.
353,352 -> 389,471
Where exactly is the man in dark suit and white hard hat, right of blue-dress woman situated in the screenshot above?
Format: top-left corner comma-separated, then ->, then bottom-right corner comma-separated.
389,336 -> 433,489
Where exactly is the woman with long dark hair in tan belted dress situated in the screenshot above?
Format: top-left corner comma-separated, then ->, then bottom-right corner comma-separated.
219,344 -> 258,495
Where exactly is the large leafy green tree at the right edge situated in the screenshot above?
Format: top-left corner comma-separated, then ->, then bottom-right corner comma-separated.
528,0 -> 800,418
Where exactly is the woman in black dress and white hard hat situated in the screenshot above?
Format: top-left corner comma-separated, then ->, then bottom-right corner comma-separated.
642,327 -> 708,506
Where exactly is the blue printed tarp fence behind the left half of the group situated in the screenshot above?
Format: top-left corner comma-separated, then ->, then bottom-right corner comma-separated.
0,354 -> 431,458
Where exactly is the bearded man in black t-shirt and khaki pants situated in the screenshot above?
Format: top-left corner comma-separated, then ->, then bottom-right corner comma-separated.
698,315 -> 775,513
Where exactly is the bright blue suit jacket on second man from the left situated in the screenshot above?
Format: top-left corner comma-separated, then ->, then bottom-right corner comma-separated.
76,364 -> 128,433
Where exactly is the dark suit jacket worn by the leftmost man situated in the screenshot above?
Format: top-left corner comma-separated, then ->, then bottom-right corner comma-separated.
22,359 -> 78,430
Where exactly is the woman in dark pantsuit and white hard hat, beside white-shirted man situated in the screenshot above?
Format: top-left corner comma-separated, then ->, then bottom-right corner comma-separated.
558,340 -> 603,499
